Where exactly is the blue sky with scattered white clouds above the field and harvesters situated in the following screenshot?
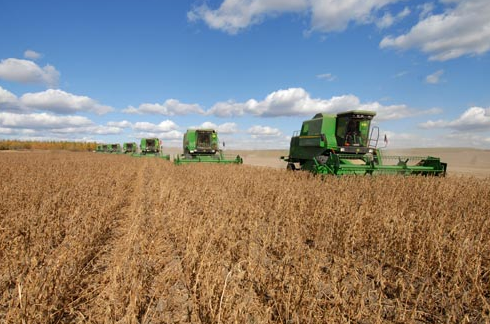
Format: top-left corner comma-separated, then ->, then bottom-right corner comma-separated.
0,0 -> 490,149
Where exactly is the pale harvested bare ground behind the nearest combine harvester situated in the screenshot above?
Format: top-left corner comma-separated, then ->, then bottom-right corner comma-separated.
223,148 -> 490,178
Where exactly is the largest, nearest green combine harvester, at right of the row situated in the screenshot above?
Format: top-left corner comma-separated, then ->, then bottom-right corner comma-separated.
281,110 -> 447,176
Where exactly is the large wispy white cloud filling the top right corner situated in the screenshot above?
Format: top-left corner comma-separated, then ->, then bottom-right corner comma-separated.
380,0 -> 490,61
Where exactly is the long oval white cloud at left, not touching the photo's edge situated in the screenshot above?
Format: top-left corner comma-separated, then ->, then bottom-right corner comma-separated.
20,89 -> 114,115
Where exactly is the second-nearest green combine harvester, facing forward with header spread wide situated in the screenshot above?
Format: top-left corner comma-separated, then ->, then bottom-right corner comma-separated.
174,129 -> 243,165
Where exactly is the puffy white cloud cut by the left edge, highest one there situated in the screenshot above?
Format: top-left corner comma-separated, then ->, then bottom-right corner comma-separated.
0,58 -> 60,87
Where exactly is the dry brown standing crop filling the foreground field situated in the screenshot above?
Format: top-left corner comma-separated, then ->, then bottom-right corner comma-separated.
0,152 -> 490,323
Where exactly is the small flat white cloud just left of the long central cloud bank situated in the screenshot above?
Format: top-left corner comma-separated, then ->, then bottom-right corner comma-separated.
123,99 -> 204,116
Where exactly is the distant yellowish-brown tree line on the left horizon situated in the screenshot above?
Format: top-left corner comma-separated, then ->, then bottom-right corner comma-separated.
0,140 -> 97,151
